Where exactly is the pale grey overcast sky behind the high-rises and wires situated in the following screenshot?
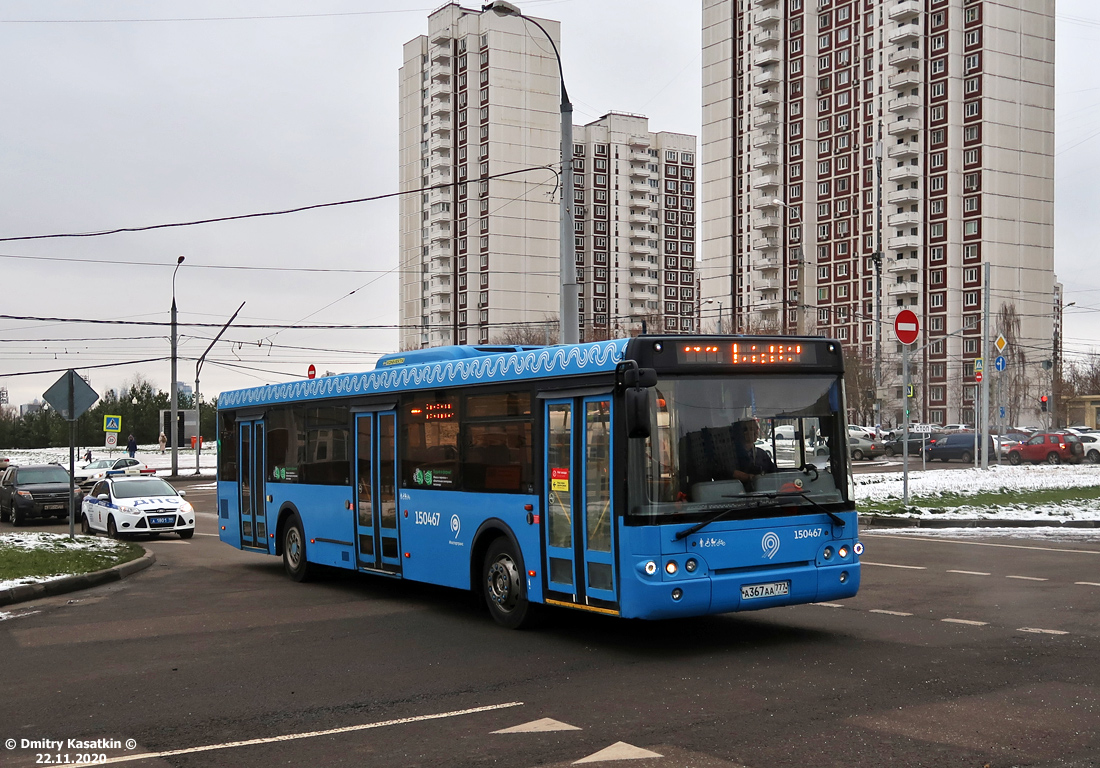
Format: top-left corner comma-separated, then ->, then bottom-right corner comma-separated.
0,0 -> 1100,413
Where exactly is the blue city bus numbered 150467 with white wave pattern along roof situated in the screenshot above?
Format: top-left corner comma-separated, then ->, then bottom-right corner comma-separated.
218,336 -> 862,627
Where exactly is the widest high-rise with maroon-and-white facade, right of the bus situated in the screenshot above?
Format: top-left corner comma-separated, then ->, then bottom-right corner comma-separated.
701,0 -> 1056,424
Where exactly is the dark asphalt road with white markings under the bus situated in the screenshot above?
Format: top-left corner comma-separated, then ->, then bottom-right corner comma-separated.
0,475 -> 1100,768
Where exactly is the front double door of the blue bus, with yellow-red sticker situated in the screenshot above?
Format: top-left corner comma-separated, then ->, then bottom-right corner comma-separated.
543,395 -> 618,613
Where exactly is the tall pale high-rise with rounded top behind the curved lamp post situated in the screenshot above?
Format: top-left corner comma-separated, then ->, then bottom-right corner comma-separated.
399,4 -> 561,349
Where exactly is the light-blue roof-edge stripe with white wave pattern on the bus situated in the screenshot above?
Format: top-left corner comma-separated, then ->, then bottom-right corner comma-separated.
218,339 -> 628,410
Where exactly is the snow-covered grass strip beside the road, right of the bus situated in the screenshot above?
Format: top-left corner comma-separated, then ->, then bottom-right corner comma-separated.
855,464 -> 1100,520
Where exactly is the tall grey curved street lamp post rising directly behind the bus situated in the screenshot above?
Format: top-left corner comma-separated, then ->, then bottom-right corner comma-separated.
482,0 -> 581,344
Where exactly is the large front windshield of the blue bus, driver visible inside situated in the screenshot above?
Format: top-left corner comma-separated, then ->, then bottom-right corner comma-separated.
628,374 -> 848,517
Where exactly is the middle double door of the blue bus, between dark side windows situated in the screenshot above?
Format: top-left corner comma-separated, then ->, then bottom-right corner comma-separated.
354,410 -> 402,573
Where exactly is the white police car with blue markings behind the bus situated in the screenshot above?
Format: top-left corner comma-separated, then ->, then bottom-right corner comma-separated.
80,475 -> 195,539
